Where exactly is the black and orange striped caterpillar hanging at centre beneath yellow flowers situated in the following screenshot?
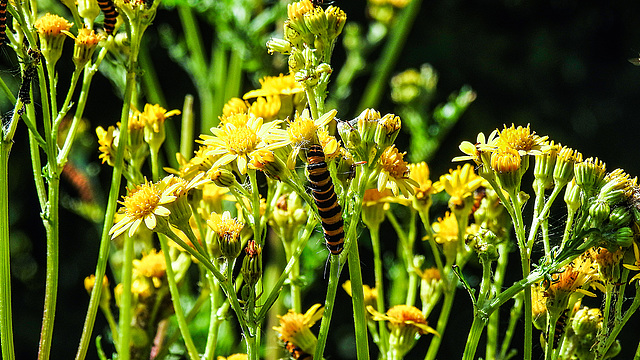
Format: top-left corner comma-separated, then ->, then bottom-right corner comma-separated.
307,145 -> 344,255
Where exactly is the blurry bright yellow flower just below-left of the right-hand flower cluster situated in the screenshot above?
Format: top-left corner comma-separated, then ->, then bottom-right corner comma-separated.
433,164 -> 484,209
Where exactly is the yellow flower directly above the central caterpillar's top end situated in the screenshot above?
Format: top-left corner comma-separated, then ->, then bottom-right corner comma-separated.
287,109 -> 338,169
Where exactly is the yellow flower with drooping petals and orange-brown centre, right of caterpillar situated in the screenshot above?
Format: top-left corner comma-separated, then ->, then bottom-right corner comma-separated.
377,145 -> 419,195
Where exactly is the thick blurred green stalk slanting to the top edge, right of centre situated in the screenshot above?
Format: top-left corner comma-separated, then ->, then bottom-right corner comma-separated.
357,0 -> 422,112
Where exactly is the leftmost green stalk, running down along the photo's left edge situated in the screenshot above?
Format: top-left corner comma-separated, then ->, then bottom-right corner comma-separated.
0,132 -> 15,360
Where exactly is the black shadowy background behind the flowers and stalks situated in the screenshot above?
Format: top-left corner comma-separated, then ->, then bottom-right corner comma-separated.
10,0 -> 640,359
